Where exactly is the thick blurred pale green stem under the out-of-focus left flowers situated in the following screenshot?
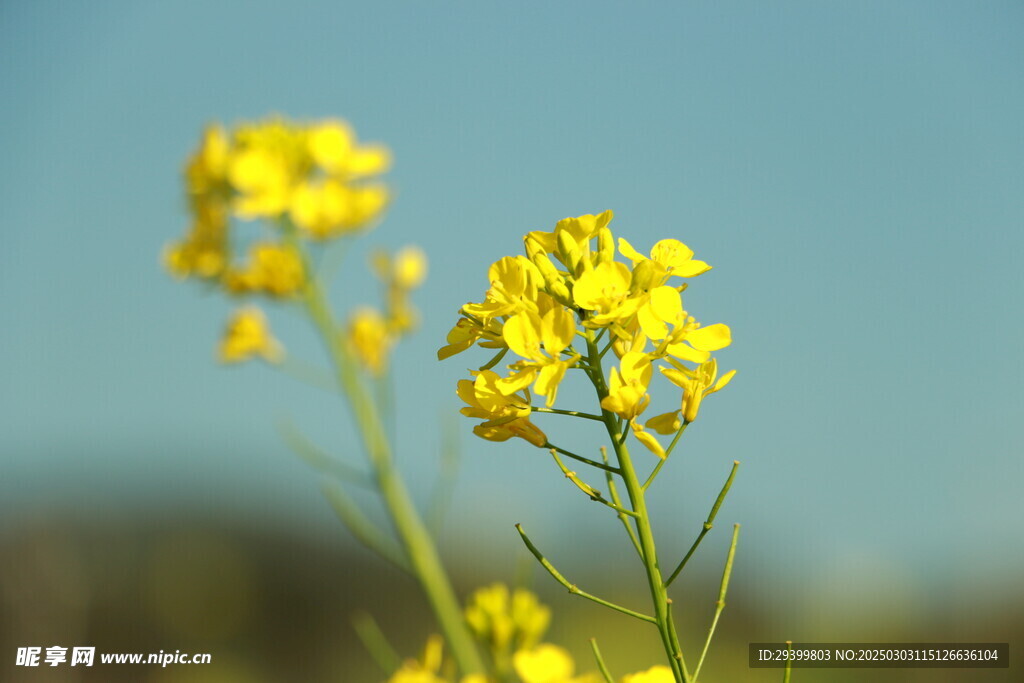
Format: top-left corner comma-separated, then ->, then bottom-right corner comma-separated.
291,234 -> 484,674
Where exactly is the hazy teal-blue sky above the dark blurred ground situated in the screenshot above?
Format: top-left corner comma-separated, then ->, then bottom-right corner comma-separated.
0,2 -> 1024,602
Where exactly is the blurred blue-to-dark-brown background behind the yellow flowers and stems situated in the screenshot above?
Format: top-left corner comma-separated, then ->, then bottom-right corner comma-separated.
0,1 -> 1024,683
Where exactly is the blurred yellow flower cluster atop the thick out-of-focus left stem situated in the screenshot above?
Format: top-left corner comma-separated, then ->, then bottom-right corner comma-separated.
164,118 -> 427,374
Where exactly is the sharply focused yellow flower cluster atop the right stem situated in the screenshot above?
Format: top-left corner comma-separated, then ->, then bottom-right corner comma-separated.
437,211 -> 734,457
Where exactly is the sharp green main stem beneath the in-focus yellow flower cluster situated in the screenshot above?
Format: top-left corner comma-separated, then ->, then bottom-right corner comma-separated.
587,330 -> 690,683
